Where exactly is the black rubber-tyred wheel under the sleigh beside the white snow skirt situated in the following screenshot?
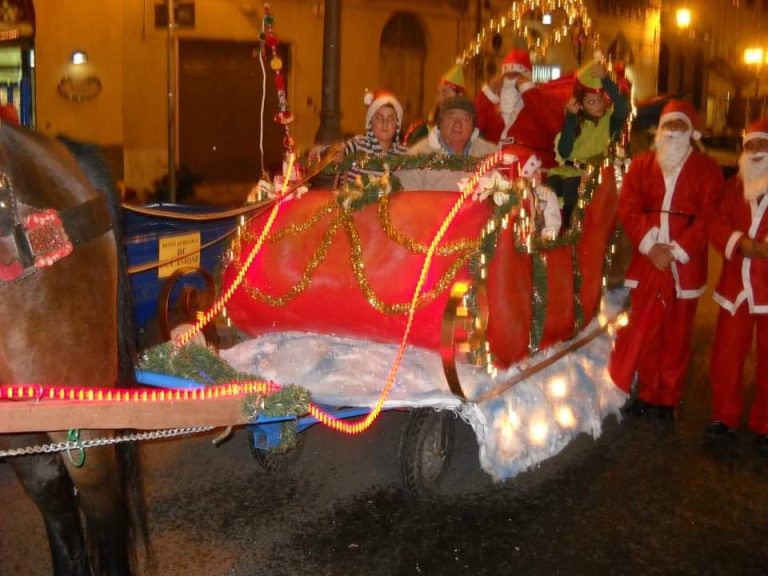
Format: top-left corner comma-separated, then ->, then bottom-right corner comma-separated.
398,408 -> 454,492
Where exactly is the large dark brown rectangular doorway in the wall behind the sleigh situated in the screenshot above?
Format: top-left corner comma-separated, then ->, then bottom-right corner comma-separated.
178,39 -> 290,183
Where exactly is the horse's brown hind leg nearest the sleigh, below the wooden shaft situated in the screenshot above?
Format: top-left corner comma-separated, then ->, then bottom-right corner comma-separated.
52,430 -> 133,576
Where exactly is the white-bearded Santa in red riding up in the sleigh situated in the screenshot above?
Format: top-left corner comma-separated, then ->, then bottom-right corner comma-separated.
475,50 -> 563,168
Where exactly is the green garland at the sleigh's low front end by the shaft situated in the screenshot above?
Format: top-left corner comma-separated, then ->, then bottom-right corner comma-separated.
139,342 -> 311,453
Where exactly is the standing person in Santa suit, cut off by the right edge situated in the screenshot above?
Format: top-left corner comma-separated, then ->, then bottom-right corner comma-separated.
706,117 -> 768,450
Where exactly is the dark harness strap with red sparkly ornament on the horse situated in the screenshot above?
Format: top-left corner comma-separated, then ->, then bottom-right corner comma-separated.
0,172 -> 112,283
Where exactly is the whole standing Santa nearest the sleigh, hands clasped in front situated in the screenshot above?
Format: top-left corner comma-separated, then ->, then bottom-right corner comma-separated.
610,100 -> 724,419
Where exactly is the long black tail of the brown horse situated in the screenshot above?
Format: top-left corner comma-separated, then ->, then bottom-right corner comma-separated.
59,136 -> 153,568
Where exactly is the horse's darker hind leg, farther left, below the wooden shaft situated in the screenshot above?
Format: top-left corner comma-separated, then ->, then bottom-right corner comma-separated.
0,435 -> 91,576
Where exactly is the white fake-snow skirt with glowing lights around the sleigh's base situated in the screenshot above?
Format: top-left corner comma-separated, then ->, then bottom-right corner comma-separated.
221,290 -> 627,481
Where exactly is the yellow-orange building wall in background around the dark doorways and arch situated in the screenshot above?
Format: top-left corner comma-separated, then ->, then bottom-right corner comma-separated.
30,0 -> 657,191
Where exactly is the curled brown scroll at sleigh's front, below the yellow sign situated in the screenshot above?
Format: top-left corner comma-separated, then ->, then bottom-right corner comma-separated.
157,266 -> 218,345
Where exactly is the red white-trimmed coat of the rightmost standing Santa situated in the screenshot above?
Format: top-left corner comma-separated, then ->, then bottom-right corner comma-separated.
710,176 -> 768,314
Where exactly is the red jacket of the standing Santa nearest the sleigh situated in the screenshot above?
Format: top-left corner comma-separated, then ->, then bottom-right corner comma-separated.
618,150 -> 723,298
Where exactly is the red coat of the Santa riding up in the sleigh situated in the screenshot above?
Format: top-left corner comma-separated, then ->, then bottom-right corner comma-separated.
475,82 -> 564,168
